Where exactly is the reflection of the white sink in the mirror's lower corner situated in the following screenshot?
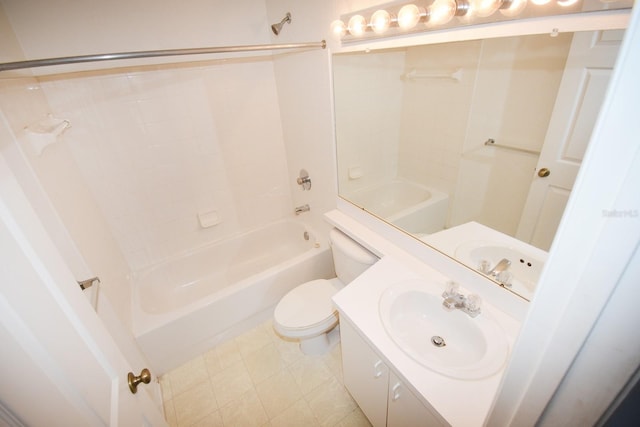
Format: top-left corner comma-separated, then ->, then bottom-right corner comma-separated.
455,240 -> 544,299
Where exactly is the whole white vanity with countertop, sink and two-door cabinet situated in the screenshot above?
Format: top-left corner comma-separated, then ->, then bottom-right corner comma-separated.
326,211 -> 521,427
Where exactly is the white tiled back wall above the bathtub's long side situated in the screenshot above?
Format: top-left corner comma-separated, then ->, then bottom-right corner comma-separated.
36,60 -> 292,270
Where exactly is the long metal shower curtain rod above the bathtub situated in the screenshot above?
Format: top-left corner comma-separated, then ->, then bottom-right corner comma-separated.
0,40 -> 327,71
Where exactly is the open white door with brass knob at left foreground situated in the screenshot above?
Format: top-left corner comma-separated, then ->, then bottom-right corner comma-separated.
0,156 -> 166,427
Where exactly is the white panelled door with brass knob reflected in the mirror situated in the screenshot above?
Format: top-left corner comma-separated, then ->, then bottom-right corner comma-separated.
516,30 -> 624,250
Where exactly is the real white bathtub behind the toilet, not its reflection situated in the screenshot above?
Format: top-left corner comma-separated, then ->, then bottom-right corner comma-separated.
133,220 -> 335,375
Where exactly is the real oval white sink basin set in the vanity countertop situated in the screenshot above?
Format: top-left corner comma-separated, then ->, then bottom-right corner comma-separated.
379,279 -> 509,380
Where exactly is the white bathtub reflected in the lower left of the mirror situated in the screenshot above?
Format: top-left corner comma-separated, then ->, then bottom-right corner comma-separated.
347,179 -> 449,235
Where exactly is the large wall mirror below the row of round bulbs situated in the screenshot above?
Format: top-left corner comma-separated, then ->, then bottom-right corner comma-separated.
333,30 -> 623,299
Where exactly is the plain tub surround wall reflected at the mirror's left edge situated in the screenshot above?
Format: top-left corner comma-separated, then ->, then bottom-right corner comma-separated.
333,51 -> 405,194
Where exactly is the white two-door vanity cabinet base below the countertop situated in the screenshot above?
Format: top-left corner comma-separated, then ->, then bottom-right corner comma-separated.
340,317 -> 447,427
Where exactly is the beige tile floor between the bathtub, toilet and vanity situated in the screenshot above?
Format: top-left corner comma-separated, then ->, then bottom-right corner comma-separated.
160,321 -> 370,427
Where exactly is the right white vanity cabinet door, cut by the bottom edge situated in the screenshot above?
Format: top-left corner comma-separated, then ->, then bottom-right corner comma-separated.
387,371 -> 447,427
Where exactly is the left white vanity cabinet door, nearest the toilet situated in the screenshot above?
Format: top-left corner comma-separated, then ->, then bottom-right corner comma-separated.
340,319 -> 389,427
